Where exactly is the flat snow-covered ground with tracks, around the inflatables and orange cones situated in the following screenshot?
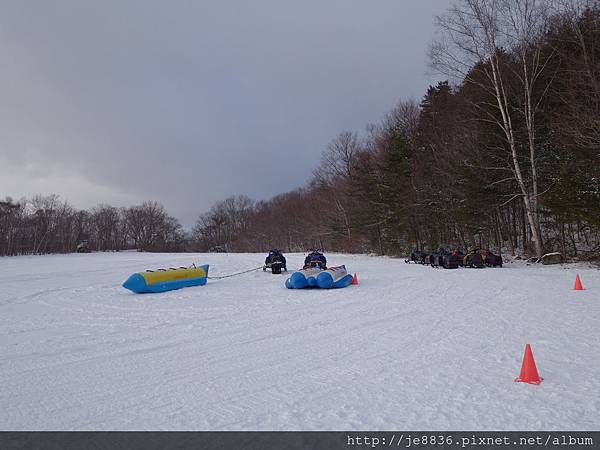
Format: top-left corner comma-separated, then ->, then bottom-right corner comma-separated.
0,253 -> 600,430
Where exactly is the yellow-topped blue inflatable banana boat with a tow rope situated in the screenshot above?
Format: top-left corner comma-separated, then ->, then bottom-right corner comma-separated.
123,264 -> 208,294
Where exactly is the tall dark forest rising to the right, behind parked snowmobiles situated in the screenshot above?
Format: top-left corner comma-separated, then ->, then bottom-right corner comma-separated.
193,0 -> 600,256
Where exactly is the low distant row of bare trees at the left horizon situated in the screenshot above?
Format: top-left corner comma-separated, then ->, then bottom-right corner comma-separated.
0,195 -> 189,256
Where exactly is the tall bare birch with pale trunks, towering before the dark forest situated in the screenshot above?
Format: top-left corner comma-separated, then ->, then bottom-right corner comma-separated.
431,0 -> 548,256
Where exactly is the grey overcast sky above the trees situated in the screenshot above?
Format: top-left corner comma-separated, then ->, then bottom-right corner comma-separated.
0,0 -> 450,227
